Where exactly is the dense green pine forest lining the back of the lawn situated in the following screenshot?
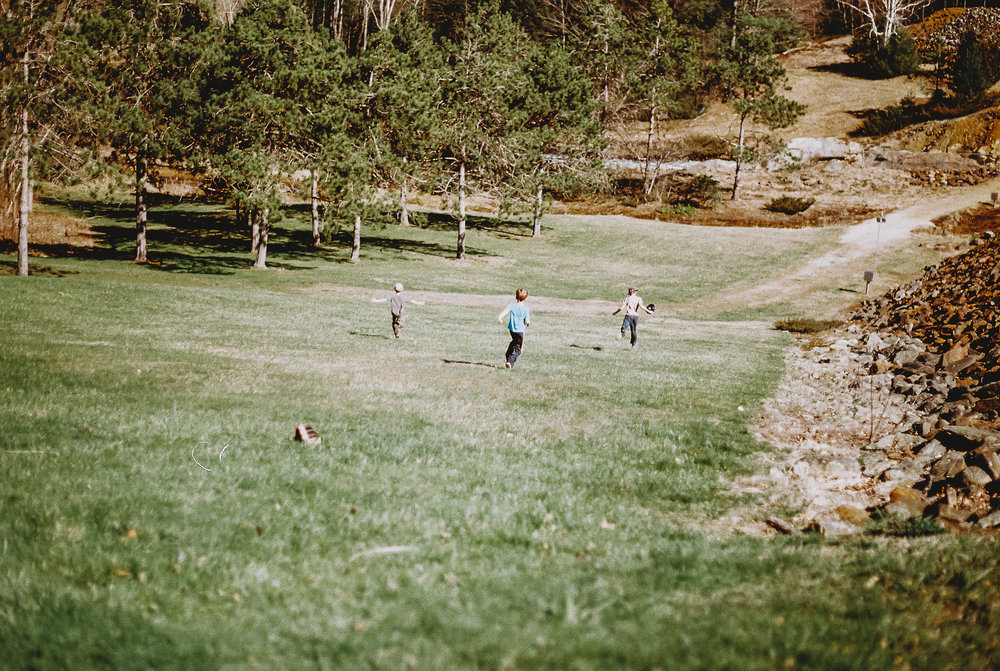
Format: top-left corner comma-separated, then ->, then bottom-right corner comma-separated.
0,0 -> 996,273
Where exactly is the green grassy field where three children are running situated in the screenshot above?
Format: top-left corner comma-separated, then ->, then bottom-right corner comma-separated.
0,197 -> 1000,669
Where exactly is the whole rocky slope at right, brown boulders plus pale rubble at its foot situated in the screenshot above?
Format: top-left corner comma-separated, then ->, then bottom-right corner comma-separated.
743,232 -> 1000,535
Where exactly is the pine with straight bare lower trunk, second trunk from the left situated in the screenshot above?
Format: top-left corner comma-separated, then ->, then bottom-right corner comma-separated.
56,0 -> 211,263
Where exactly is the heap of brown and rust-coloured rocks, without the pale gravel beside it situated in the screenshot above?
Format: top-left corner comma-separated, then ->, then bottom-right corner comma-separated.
828,232 -> 1000,529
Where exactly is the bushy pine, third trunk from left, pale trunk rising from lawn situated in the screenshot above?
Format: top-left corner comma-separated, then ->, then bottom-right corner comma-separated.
193,0 -> 352,268
